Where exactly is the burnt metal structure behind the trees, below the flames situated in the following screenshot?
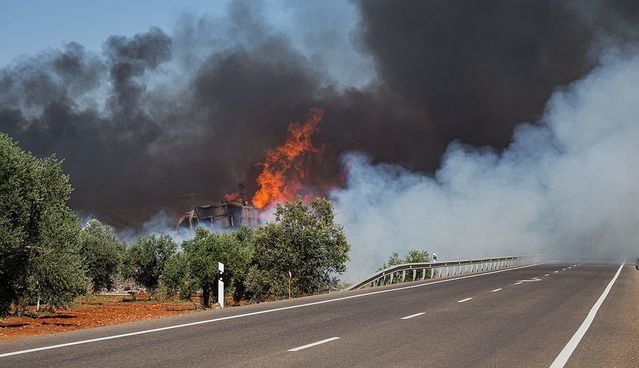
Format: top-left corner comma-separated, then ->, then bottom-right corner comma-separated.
177,201 -> 259,230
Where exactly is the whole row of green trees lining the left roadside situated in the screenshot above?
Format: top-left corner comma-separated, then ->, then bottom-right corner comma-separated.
0,133 -> 350,318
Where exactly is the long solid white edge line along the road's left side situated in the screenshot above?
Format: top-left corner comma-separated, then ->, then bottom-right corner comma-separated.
0,263 -> 542,358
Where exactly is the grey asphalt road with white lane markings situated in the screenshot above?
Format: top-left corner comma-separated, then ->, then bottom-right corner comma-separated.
0,264 -> 639,368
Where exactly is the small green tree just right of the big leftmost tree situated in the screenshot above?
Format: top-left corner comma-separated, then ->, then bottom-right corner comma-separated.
80,219 -> 126,292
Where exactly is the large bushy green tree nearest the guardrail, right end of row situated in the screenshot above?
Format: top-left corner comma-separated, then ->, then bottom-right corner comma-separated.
247,198 -> 350,299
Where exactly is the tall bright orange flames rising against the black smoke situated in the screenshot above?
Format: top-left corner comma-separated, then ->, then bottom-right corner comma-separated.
253,108 -> 324,208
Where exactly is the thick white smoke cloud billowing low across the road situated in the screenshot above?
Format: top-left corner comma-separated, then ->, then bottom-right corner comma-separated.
331,52 -> 639,281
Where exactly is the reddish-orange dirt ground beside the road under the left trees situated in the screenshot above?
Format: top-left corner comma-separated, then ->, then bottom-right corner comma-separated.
0,295 -> 198,340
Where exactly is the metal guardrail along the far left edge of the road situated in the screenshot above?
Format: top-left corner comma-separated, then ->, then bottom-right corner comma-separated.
346,256 -> 537,290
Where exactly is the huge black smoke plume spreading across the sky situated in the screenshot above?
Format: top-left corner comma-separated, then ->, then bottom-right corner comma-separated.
0,0 -> 639,227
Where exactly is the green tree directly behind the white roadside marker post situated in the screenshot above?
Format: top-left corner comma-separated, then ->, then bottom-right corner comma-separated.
182,228 -> 255,307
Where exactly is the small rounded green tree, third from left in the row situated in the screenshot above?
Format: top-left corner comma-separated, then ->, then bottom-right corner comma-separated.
124,234 -> 177,293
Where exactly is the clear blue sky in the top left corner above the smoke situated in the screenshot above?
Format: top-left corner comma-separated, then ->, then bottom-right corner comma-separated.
0,0 -> 228,66
